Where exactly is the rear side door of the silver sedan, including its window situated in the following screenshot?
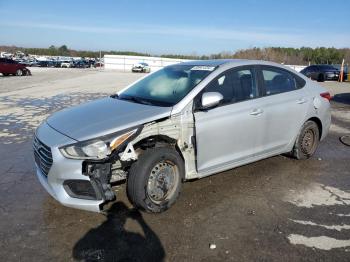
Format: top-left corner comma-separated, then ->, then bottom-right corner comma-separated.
259,66 -> 309,154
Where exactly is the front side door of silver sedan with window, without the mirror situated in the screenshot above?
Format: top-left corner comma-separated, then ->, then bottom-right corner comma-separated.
194,66 -> 263,174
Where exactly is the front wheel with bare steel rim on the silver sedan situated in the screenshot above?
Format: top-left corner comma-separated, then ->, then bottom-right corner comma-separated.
127,147 -> 185,213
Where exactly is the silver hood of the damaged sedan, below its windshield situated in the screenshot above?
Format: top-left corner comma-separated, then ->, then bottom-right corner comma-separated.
46,97 -> 172,141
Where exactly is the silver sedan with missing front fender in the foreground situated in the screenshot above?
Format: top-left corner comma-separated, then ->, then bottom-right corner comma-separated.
34,60 -> 331,213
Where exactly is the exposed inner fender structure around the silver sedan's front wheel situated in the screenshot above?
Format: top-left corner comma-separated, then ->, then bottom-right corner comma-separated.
66,101 -> 198,210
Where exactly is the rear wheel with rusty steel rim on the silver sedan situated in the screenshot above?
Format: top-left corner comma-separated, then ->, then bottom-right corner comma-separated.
292,121 -> 320,160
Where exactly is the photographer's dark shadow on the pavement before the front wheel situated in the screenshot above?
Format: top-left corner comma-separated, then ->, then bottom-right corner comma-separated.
73,202 -> 165,262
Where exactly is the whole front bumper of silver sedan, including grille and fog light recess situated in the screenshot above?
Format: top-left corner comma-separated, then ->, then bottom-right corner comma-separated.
34,123 -> 115,212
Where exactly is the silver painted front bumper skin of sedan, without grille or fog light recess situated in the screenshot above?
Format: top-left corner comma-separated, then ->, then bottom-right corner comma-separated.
36,122 -> 106,212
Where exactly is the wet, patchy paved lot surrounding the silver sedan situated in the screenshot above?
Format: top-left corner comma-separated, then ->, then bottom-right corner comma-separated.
0,68 -> 350,261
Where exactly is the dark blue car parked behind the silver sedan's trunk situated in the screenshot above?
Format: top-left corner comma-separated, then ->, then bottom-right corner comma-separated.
300,65 -> 340,82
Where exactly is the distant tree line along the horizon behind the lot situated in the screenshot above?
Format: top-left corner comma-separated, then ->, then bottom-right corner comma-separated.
0,45 -> 350,65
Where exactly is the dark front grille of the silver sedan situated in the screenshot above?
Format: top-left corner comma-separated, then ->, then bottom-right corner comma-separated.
33,136 -> 52,176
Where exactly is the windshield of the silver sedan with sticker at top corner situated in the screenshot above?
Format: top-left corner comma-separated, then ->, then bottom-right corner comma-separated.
119,64 -> 215,106
